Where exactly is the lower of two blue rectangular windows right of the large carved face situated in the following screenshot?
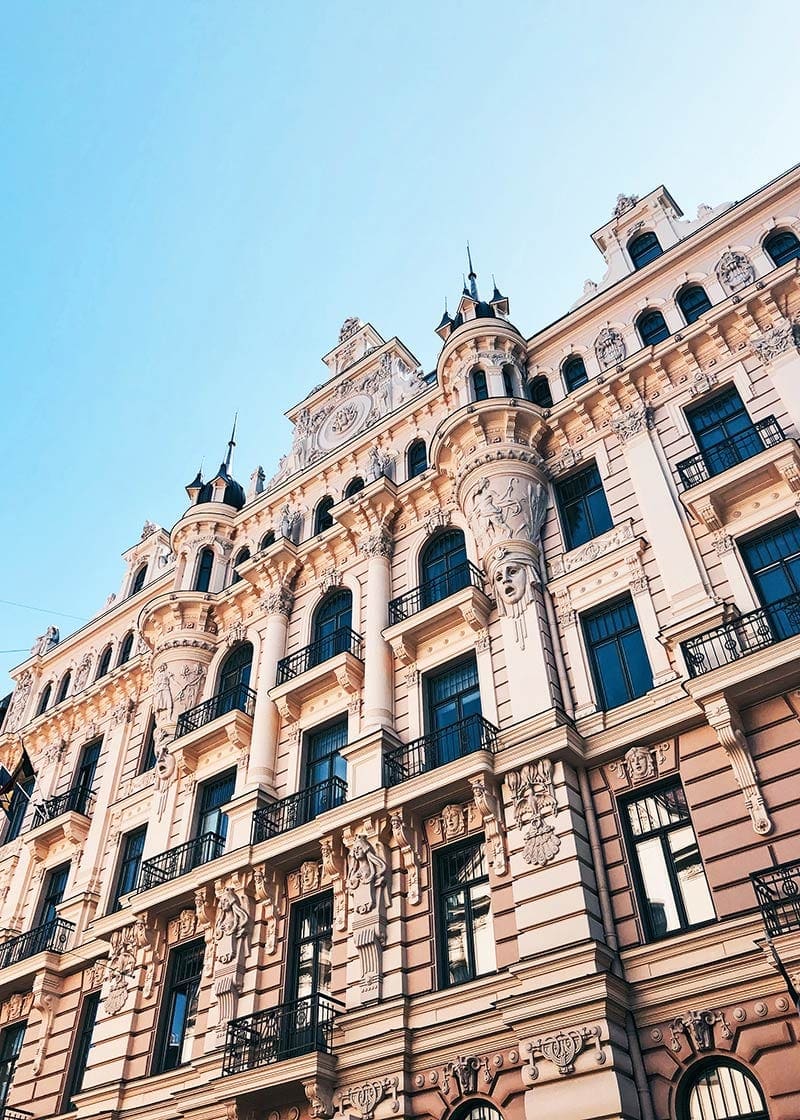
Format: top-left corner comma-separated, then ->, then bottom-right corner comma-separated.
582,595 -> 653,711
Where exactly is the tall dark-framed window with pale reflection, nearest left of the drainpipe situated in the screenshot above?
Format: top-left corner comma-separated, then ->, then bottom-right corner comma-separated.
435,836 -> 496,988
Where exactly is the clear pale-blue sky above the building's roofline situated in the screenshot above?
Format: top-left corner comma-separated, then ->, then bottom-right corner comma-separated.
0,0 -> 800,694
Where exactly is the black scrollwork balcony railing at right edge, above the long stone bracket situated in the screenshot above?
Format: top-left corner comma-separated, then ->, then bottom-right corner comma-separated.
680,594 -> 800,676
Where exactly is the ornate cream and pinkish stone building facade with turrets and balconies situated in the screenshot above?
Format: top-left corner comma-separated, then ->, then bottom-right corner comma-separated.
0,170 -> 800,1120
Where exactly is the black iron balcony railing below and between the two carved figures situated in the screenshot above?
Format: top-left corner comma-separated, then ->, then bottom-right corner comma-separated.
222,992 -> 341,1076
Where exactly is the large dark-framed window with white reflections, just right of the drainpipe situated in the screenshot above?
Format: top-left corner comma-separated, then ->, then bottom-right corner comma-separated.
622,782 -> 715,941
